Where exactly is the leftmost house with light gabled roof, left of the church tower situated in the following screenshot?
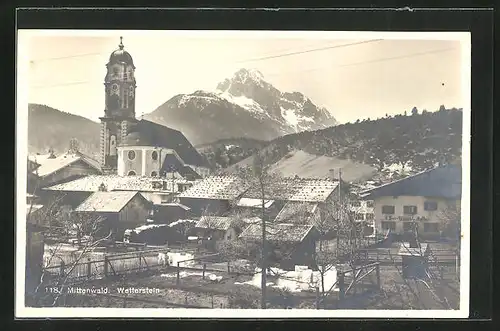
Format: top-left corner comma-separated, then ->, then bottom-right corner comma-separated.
28,151 -> 101,193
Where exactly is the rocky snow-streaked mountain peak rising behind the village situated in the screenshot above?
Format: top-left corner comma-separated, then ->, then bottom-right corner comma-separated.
145,69 -> 337,144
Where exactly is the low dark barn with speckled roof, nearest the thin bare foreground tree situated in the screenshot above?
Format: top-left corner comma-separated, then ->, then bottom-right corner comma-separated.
239,222 -> 319,270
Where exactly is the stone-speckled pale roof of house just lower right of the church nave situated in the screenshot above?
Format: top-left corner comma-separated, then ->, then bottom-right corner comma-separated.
179,176 -> 248,200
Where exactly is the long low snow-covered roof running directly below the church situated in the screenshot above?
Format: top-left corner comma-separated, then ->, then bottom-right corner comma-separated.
45,175 -> 191,193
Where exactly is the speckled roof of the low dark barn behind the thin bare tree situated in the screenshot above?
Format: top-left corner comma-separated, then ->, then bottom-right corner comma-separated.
239,223 -> 315,242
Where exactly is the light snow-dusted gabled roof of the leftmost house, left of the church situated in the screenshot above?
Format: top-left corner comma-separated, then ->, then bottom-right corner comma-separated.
28,152 -> 101,177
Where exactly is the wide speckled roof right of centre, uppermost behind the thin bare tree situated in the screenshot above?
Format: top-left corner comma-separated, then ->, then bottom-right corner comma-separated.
243,178 -> 339,202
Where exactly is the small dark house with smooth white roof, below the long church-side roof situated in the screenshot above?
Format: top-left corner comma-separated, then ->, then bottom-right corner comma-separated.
74,191 -> 152,240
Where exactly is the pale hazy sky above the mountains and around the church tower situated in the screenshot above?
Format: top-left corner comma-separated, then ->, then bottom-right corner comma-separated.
19,31 -> 464,122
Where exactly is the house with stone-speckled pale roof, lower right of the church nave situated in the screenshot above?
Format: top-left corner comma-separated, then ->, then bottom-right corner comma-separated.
177,176 -> 248,217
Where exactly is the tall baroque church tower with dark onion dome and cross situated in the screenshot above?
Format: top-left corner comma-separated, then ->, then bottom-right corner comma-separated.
100,37 -> 137,173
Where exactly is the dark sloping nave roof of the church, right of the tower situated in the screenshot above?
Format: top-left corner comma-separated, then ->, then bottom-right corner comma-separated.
121,120 -> 208,167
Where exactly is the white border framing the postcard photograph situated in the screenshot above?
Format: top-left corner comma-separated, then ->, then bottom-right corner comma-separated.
15,30 -> 471,318
